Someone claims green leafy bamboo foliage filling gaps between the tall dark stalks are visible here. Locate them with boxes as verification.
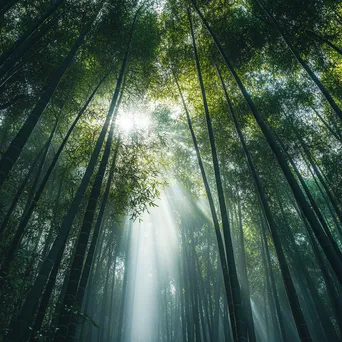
[0,0,342,340]
